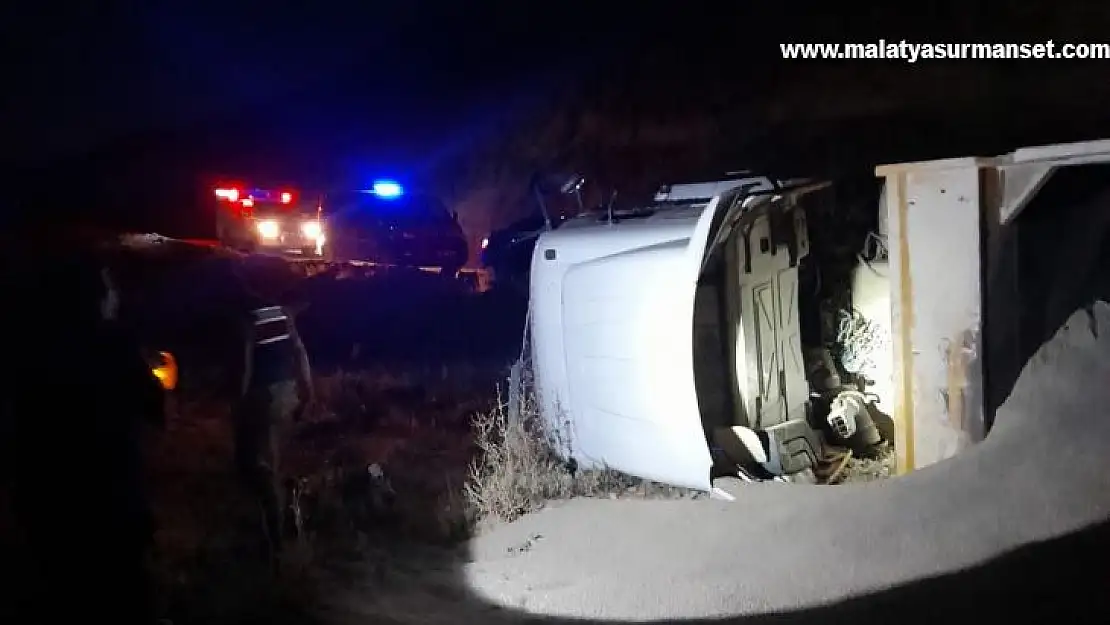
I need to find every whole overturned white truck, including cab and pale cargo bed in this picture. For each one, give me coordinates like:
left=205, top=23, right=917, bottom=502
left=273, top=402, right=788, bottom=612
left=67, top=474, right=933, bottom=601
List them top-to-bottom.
left=531, top=141, right=1110, bottom=492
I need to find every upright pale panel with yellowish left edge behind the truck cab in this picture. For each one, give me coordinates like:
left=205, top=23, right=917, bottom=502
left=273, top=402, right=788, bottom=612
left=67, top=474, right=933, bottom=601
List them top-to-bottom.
left=885, top=163, right=982, bottom=473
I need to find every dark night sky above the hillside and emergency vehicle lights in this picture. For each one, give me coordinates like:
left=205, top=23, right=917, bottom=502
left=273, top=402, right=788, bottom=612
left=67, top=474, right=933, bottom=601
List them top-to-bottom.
left=0, top=0, right=1110, bottom=232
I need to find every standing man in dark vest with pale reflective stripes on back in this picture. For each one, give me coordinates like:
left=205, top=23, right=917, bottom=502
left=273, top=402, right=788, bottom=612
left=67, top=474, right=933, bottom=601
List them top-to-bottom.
left=232, top=264, right=314, bottom=568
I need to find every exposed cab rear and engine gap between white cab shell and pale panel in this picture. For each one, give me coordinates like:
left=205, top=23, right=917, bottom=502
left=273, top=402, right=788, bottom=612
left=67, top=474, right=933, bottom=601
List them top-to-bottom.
left=692, top=175, right=891, bottom=482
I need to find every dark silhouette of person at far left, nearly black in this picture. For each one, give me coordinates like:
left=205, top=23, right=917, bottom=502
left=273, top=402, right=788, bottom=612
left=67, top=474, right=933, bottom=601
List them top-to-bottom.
left=2, top=254, right=164, bottom=623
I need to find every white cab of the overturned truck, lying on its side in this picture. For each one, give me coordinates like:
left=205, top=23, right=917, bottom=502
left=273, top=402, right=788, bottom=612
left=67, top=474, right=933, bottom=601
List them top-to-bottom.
left=532, top=172, right=880, bottom=488
